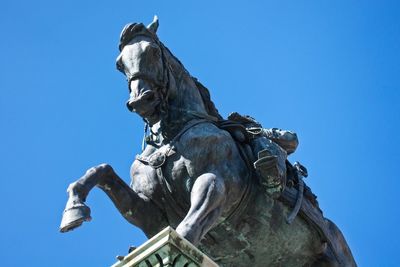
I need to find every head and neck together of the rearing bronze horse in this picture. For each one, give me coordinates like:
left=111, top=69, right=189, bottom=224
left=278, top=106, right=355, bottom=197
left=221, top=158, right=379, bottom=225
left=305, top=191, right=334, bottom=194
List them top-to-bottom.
left=117, top=17, right=222, bottom=130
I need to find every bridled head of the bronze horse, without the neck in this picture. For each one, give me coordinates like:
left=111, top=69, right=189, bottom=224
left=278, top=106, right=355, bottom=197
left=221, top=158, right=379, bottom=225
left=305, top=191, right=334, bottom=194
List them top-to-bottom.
left=117, top=17, right=170, bottom=124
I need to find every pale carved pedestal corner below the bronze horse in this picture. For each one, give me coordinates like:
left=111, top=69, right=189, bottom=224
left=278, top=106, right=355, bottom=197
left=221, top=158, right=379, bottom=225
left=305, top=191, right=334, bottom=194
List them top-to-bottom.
left=112, top=227, right=218, bottom=267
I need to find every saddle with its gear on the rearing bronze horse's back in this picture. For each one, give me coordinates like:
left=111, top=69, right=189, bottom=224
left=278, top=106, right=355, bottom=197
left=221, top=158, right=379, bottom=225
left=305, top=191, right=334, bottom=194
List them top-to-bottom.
left=218, top=112, right=298, bottom=199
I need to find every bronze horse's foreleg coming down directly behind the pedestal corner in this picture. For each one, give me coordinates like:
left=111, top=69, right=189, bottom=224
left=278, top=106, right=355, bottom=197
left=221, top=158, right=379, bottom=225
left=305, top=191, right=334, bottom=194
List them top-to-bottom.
left=176, top=173, right=226, bottom=245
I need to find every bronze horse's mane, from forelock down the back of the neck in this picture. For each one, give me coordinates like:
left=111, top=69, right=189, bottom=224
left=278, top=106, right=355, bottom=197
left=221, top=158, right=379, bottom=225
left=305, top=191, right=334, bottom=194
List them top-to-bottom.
left=117, top=23, right=223, bottom=120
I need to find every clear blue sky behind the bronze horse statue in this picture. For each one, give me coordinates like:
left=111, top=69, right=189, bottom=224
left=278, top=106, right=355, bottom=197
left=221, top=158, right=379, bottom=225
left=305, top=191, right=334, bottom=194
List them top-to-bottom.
left=0, top=0, right=400, bottom=267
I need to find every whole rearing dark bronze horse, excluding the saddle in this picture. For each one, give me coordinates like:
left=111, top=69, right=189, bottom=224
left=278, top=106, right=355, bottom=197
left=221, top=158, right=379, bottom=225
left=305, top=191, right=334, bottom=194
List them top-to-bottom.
left=60, top=18, right=356, bottom=266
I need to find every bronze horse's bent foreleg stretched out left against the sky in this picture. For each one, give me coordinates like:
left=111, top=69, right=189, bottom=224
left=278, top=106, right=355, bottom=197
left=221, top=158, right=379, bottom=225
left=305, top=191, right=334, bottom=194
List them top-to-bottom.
left=60, top=164, right=166, bottom=237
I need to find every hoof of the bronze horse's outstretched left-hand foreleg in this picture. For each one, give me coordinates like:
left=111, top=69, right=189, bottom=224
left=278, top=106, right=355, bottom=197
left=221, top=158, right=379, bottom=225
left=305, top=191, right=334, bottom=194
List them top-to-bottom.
left=60, top=203, right=92, bottom=233
